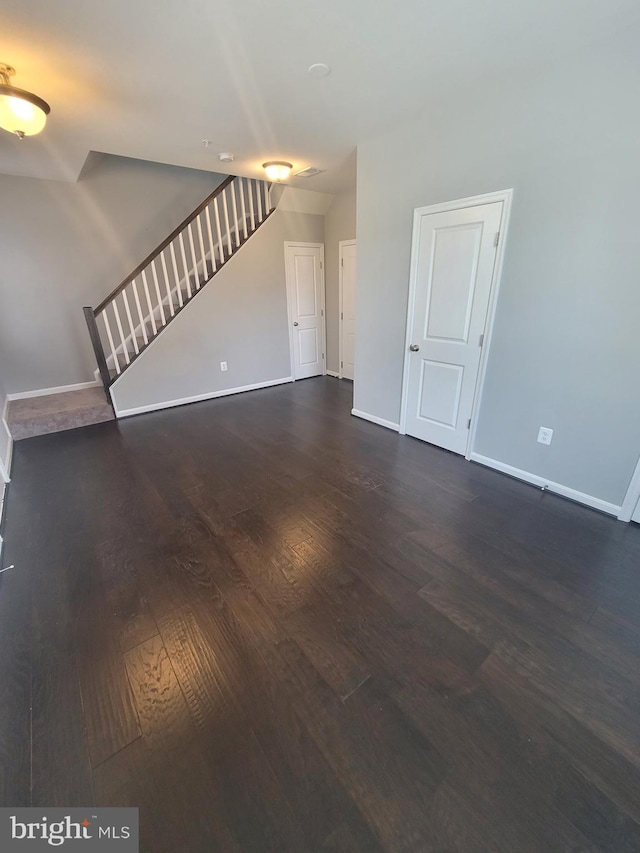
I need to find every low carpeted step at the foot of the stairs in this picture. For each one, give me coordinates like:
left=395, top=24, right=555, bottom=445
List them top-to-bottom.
left=7, top=388, right=114, bottom=441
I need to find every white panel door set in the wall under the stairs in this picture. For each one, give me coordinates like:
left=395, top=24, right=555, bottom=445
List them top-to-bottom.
left=286, top=243, right=324, bottom=379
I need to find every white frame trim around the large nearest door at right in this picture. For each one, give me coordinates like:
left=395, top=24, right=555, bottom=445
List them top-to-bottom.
left=399, top=188, right=513, bottom=459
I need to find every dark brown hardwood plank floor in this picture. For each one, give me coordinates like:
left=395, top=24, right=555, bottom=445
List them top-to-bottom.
left=0, top=379, right=640, bottom=853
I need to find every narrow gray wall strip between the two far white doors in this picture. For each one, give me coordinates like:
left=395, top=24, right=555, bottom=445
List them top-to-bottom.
left=324, top=188, right=356, bottom=373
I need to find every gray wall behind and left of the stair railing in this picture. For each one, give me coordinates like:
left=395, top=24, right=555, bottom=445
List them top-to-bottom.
left=0, top=154, right=224, bottom=393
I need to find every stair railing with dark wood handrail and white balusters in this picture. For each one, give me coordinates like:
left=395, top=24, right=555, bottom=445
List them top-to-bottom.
left=84, top=175, right=274, bottom=391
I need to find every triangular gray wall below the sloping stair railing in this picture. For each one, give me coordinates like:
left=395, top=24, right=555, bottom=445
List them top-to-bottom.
left=113, top=210, right=324, bottom=411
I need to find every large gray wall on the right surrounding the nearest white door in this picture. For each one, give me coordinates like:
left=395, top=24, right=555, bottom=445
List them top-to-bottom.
left=354, top=36, right=640, bottom=504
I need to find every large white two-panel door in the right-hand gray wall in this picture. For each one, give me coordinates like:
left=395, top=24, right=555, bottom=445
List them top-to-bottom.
left=405, top=201, right=503, bottom=453
